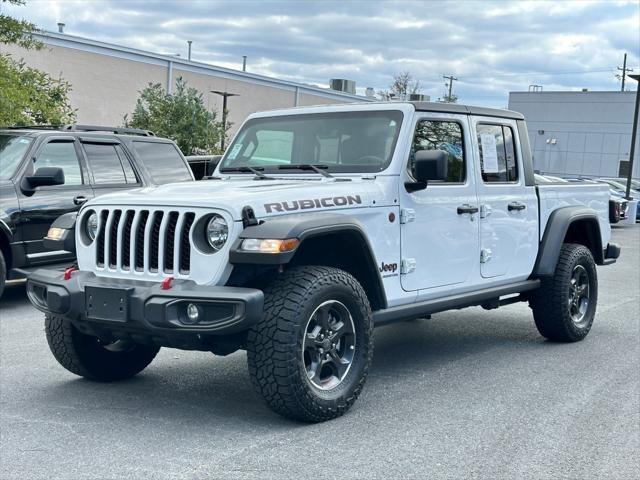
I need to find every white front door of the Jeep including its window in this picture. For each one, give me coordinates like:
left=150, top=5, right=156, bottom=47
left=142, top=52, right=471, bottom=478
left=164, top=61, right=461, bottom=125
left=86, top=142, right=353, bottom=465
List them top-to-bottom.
left=400, top=113, right=479, bottom=291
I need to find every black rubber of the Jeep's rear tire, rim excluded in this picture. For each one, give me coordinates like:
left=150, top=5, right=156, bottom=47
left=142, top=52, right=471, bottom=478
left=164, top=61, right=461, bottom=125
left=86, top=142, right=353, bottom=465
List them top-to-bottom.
left=529, top=243, right=598, bottom=342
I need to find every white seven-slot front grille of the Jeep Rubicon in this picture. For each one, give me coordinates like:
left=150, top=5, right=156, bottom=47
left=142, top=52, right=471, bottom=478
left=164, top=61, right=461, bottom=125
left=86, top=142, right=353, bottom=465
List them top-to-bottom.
left=96, top=209, right=195, bottom=275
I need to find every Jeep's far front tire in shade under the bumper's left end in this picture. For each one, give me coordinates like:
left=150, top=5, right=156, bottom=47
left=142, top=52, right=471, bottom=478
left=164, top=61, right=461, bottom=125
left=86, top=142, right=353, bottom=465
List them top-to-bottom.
left=45, top=315, right=160, bottom=382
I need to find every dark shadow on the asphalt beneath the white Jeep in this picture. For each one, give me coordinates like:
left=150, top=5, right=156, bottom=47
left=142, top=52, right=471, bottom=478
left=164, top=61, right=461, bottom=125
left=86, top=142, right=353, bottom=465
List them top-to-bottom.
left=35, top=313, right=548, bottom=429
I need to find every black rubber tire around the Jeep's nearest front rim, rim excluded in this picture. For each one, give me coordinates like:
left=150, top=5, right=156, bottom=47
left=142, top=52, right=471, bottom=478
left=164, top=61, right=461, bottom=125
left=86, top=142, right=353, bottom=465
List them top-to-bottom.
left=247, top=266, right=373, bottom=422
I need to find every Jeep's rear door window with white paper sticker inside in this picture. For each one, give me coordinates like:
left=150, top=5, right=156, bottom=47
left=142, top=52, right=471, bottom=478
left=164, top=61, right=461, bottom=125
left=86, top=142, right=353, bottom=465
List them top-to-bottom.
left=477, top=124, right=518, bottom=183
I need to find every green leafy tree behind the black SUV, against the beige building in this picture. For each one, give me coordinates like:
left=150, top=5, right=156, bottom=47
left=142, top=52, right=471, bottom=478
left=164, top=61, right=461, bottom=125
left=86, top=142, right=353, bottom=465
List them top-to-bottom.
left=124, top=77, right=229, bottom=155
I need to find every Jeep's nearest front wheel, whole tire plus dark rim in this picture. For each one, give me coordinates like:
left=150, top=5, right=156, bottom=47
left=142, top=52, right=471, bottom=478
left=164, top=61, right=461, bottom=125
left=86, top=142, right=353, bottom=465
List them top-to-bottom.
left=247, top=266, right=373, bottom=422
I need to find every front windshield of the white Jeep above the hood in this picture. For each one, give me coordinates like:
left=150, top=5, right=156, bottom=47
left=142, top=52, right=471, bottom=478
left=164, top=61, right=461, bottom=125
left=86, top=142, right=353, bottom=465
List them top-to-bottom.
left=220, top=110, right=402, bottom=173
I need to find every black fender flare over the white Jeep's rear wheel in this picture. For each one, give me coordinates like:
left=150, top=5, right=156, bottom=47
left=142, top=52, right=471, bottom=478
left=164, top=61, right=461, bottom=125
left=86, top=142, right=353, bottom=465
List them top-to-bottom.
left=533, top=206, right=604, bottom=277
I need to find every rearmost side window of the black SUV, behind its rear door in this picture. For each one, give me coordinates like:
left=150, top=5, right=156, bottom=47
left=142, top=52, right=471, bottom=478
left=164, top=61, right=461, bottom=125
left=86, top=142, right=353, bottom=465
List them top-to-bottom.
left=133, top=141, right=193, bottom=185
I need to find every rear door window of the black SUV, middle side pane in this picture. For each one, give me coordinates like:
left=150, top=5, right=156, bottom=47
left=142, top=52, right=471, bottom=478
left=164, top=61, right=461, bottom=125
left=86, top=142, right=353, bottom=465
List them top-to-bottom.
left=83, top=143, right=138, bottom=185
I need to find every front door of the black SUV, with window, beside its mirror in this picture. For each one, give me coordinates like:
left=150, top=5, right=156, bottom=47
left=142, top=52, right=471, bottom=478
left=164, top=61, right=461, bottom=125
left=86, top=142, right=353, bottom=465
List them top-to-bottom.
left=19, top=136, right=93, bottom=265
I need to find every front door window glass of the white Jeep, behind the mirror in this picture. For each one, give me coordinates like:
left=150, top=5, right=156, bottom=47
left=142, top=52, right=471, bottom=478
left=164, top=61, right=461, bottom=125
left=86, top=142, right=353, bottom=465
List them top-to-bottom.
left=409, top=120, right=466, bottom=183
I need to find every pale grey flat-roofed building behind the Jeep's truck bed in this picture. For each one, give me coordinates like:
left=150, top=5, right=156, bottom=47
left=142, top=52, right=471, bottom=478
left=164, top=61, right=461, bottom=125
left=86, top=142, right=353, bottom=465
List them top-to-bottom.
left=509, top=91, right=640, bottom=178
